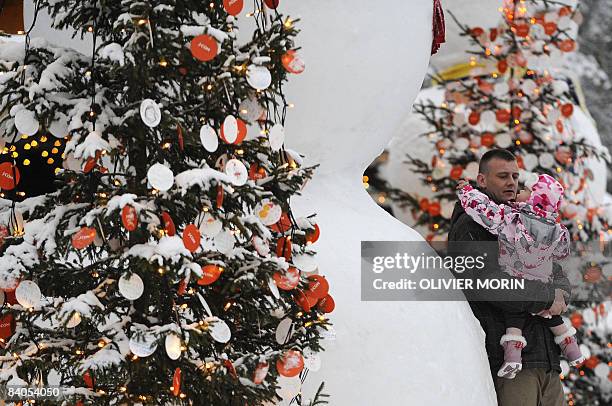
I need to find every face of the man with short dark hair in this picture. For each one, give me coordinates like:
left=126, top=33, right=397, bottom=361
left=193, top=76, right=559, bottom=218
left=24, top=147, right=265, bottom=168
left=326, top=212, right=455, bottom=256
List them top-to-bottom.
left=476, top=158, right=519, bottom=203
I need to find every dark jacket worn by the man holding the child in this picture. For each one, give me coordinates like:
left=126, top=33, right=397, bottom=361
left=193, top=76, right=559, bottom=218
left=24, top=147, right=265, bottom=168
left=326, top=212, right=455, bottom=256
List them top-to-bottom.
left=448, top=203, right=571, bottom=376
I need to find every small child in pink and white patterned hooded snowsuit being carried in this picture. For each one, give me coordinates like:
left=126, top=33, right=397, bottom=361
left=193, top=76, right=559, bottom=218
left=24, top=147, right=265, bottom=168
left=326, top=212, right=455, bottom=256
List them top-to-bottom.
left=457, top=175, right=584, bottom=379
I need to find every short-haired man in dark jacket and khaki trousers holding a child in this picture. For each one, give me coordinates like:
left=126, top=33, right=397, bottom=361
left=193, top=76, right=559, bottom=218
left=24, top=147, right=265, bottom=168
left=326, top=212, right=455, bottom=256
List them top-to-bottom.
left=448, top=149, right=570, bottom=406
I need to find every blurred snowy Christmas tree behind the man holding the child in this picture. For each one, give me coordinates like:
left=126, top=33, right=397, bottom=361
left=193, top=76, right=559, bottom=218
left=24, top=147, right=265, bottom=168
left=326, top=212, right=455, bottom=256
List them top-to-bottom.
left=370, top=0, right=612, bottom=405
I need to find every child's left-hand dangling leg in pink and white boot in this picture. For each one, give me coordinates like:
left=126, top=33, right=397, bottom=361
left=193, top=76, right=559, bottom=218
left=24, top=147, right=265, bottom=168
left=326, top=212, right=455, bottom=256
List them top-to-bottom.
left=497, top=312, right=527, bottom=379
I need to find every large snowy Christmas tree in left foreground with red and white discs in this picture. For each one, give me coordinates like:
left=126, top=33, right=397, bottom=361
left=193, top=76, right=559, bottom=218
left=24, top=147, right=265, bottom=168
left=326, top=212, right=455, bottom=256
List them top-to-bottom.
left=0, top=0, right=334, bottom=405
